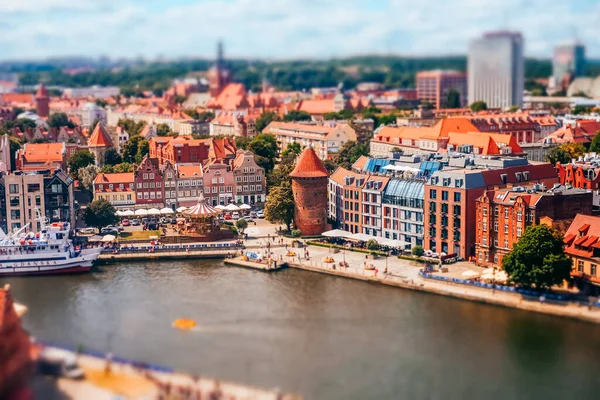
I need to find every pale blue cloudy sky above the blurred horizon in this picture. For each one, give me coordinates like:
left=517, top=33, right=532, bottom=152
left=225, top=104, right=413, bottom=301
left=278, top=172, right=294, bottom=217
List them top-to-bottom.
left=0, top=0, right=600, bottom=60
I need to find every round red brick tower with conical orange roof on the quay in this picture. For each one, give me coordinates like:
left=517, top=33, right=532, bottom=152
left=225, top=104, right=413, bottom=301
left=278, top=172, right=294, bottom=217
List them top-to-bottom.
left=290, top=147, right=329, bottom=236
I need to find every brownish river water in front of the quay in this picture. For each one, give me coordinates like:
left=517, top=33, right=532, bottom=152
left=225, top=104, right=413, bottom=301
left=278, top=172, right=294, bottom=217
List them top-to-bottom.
left=0, top=260, right=600, bottom=399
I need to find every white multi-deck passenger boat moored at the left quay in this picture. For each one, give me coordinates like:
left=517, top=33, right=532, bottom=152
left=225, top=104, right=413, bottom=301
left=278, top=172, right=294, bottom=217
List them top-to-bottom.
left=0, top=209, right=102, bottom=276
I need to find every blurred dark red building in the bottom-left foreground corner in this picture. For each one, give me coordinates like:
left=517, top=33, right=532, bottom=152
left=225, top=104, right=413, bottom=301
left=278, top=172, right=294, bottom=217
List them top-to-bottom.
left=0, top=285, right=32, bottom=399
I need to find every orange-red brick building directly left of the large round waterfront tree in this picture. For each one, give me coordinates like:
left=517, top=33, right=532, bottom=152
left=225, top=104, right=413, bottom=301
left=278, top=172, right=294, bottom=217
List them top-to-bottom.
left=475, top=185, right=592, bottom=265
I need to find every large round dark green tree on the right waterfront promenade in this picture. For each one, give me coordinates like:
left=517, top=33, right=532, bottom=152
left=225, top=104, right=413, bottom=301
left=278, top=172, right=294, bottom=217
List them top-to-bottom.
left=502, top=225, right=572, bottom=289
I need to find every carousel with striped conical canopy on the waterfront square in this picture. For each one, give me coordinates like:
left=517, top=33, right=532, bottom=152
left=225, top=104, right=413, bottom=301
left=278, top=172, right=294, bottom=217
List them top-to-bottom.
left=177, top=193, right=233, bottom=241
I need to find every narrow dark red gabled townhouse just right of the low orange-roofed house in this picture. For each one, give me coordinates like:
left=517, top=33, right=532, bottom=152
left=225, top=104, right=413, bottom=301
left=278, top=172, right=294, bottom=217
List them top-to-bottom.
left=133, top=156, right=165, bottom=208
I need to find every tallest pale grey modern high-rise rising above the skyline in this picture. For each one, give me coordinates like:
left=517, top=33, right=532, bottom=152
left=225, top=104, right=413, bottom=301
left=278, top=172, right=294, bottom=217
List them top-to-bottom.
left=467, top=31, right=525, bottom=108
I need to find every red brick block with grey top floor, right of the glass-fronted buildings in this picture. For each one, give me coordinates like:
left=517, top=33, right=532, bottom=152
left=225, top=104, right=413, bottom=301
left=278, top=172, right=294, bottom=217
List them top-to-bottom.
left=424, top=158, right=558, bottom=259
